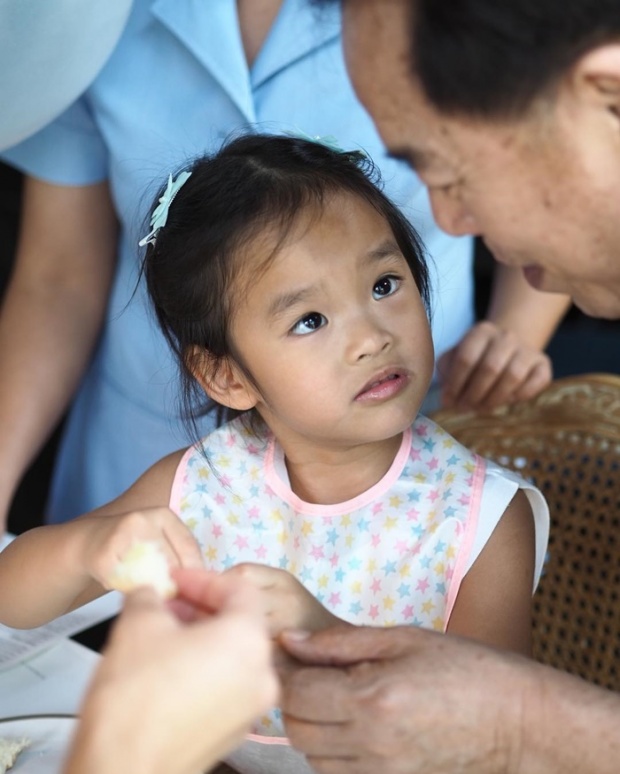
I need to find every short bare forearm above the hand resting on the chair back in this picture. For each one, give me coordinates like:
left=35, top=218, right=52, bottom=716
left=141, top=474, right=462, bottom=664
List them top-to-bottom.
left=486, top=265, right=571, bottom=350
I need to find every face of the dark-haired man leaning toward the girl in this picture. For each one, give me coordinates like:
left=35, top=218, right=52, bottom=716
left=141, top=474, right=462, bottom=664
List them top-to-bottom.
left=344, top=0, right=620, bottom=317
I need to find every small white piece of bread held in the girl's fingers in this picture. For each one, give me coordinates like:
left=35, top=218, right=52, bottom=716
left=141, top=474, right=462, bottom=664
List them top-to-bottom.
left=108, top=540, right=177, bottom=599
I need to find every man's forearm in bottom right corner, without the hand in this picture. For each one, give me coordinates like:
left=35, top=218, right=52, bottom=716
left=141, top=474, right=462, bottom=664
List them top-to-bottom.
left=511, top=668, right=620, bottom=774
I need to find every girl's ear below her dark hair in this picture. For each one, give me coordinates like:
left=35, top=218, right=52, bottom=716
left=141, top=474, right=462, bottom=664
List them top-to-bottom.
left=187, top=347, right=257, bottom=411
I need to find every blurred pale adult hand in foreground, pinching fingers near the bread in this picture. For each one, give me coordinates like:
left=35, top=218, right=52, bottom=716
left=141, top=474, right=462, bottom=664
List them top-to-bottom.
left=65, top=570, right=277, bottom=774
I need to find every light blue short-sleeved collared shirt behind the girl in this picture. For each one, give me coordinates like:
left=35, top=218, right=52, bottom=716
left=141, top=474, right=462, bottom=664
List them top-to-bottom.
left=4, top=0, right=473, bottom=520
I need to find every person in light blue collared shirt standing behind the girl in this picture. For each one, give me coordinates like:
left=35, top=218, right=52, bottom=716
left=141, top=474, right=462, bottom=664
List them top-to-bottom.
left=0, top=0, right=566, bottom=521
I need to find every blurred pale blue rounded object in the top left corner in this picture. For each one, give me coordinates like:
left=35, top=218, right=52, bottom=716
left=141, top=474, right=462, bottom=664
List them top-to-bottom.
left=0, top=0, right=131, bottom=150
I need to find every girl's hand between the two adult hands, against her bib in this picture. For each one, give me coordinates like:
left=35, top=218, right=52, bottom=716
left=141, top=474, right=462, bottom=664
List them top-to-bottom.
left=225, top=563, right=342, bottom=637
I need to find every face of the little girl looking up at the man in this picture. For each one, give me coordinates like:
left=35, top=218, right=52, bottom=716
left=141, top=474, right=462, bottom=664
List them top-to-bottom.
left=225, top=194, right=433, bottom=452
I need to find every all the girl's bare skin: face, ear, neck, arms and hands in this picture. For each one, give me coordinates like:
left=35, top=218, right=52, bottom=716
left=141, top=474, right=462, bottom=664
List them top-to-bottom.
left=0, top=189, right=535, bottom=654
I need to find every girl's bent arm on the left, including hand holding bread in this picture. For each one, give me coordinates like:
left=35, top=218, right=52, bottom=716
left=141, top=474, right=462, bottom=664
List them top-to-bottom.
left=0, top=452, right=203, bottom=628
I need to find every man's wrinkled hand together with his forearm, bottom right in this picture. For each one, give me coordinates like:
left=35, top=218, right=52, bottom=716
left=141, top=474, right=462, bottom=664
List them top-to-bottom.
left=280, top=627, right=620, bottom=774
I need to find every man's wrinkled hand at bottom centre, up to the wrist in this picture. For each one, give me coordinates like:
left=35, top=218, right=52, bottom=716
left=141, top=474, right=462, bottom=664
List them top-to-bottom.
left=280, top=627, right=533, bottom=774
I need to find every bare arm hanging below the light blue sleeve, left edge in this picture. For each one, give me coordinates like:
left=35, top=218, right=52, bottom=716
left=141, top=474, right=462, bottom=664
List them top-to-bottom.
left=0, top=179, right=117, bottom=527
